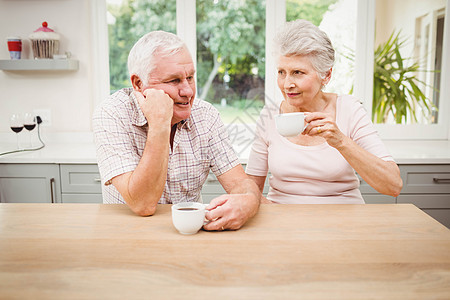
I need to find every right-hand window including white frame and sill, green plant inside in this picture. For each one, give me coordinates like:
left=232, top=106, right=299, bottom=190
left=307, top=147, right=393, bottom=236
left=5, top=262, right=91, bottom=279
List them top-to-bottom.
left=356, top=0, right=450, bottom=139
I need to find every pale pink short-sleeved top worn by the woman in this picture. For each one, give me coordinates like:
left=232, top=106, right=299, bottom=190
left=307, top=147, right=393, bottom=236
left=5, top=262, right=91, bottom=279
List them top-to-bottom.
left=246, top=95, right=394, bottom=204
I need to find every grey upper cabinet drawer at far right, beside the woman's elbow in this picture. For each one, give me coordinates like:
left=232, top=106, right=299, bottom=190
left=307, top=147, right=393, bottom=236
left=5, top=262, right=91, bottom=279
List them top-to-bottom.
left=400, top=165, right=450, bottom=194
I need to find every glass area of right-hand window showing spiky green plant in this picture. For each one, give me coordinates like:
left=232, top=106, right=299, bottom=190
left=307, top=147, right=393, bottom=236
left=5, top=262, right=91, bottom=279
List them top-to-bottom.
left=372, top=0, right=445, bottom=125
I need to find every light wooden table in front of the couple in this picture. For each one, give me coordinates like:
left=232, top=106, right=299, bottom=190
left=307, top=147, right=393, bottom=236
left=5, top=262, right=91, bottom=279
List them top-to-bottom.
left=0, top=204, right=450, bottom=299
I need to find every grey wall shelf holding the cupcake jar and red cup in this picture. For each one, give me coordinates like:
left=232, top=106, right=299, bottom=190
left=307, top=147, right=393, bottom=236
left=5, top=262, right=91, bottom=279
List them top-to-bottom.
left=0, top=59, right=78, bottom=71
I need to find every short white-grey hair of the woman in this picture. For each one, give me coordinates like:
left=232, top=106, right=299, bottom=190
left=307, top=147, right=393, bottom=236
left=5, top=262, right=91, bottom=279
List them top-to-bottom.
left=274, top=19, right=334, bottom=77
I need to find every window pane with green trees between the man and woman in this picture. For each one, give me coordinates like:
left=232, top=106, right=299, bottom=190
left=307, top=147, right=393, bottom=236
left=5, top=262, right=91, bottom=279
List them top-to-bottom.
left=196, top=0, right=266, bottom=124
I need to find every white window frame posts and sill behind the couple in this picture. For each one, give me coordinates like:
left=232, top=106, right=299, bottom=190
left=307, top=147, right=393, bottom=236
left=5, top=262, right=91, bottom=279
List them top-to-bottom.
left=95, top=0, right=450, bottom=140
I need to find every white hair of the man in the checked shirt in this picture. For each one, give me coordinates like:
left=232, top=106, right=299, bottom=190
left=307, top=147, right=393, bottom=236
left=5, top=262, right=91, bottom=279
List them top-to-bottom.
left=128, top=31, right=185, bottom=84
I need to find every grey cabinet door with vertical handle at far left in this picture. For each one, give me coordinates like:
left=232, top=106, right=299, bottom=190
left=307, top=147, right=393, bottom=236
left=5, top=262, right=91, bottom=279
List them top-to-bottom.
left=0, top=164, right=61, bottom=203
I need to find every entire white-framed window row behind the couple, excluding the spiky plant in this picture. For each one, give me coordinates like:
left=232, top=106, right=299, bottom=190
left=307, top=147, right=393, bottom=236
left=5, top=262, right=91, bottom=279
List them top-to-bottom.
left=91, top=0, right=450, bottom=143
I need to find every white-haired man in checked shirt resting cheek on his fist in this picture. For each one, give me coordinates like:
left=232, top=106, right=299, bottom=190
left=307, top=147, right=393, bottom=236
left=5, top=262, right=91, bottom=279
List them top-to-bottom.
left=93, top=31, right=261, bottom=230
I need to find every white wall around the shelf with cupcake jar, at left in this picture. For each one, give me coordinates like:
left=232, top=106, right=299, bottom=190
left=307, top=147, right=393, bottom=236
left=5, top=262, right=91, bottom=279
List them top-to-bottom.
left=0, top=0, right=99, bottom=135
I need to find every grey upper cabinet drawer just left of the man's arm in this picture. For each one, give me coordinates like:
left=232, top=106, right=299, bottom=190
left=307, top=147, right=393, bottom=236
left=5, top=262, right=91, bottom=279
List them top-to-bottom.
left=61, top=165, right=102, bottom=194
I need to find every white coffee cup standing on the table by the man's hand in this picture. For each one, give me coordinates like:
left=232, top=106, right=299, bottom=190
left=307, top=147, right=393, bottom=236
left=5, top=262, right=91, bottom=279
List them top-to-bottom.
left=172, top=202, right=206, bottom=234
